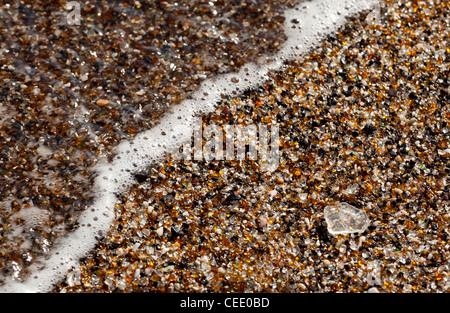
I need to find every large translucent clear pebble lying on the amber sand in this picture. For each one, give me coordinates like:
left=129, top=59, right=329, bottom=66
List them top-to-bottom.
left=324, top=202, right=369, bottom=235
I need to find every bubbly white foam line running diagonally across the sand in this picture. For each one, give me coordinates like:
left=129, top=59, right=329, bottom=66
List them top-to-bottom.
left=0, top=0, right=378, bottom=292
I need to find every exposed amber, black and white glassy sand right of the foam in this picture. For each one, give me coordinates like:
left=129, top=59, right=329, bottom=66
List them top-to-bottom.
left=54, top=1, right=450, bottom=292
